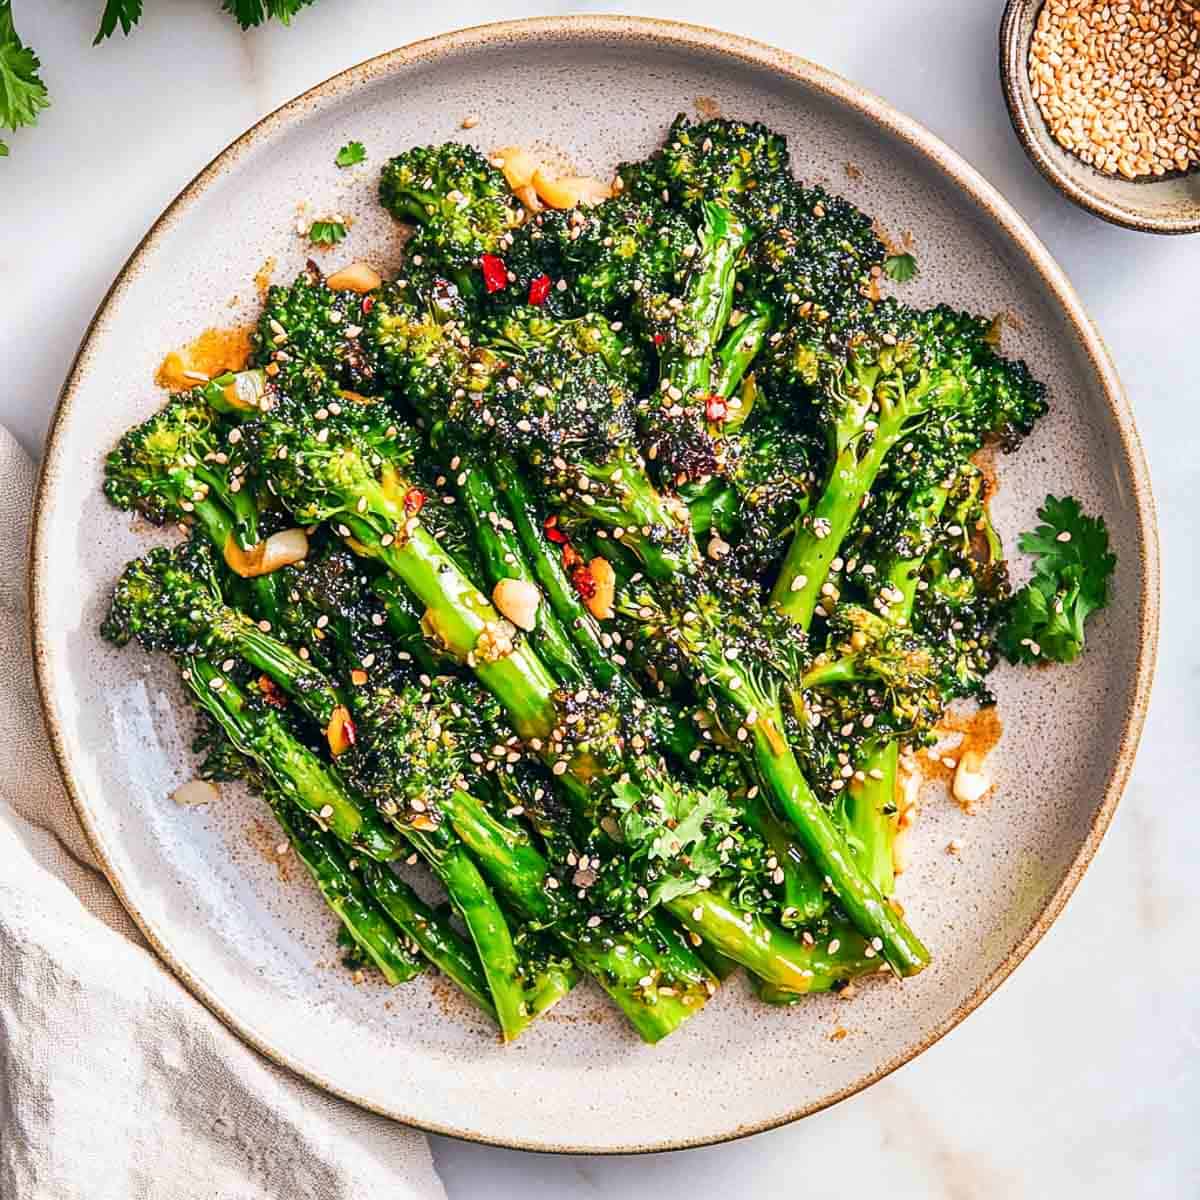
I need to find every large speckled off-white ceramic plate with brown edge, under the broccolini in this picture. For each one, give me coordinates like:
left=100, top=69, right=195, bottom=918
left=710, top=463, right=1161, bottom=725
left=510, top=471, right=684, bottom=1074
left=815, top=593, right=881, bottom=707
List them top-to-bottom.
left=32, top=17, right=1158, bottom=1152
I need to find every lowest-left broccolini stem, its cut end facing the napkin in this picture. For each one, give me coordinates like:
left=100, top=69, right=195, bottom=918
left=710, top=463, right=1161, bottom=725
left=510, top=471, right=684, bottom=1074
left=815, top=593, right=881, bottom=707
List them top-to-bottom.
left=269, top=791, right=424, bottom=984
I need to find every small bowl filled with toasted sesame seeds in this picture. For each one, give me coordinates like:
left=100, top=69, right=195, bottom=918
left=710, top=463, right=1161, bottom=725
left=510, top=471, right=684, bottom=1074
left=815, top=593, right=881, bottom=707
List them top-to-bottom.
left=1000, top=0, right=1200, bottom=233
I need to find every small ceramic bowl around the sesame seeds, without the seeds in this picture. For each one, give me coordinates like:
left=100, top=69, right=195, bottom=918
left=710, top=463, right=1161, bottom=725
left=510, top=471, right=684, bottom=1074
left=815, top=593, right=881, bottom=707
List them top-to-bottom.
left=1000, top=0, right=1200, bottom=233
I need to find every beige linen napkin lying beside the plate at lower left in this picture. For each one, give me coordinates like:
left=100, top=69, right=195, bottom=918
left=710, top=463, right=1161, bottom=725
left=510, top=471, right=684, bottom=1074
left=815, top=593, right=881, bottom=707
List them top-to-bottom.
left=0, top=427, right=445, bottom=1200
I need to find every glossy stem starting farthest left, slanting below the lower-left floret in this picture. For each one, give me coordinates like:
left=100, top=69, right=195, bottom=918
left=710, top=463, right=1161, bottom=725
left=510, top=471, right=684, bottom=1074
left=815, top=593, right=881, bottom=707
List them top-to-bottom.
left=180, top=656, right=404, bottom=862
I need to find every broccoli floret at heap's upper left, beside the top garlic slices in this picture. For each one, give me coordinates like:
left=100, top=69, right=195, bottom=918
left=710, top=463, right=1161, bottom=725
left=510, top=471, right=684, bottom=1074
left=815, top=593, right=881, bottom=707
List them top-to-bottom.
left=379, top=142, right=521, bottom=285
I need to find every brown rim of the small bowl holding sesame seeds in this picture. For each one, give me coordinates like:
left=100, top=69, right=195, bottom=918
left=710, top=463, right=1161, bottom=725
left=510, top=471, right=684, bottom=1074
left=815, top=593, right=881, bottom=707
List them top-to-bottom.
left=1000, top=0, right=1200, bottom=234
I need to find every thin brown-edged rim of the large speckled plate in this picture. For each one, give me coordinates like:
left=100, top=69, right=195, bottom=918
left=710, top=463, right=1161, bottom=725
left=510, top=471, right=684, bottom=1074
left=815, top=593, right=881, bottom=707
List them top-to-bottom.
left=28, top=13, right=1159, bottom=1154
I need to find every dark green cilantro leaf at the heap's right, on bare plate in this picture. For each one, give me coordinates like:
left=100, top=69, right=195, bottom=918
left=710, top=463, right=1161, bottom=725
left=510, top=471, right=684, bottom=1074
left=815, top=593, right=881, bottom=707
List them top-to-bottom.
left=1000, top=496, right=1117, bottom=664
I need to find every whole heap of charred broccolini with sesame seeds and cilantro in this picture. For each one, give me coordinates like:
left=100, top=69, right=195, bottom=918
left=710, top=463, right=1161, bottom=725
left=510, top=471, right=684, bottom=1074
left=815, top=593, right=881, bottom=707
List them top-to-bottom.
left=96, top=118, right=1112, bottom=1042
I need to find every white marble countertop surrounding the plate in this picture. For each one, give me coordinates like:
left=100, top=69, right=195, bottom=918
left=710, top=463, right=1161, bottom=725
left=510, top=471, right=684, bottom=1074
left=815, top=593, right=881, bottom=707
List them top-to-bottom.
left=0, top=0, right=1200, bottom=1200
